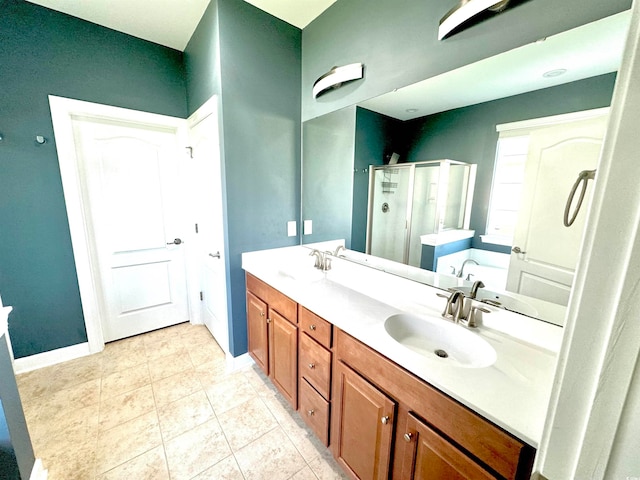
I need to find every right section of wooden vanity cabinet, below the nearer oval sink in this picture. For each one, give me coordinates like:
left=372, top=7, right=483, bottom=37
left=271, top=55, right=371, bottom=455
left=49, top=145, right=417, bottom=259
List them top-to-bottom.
left=331, top=329, right=535, bottom=480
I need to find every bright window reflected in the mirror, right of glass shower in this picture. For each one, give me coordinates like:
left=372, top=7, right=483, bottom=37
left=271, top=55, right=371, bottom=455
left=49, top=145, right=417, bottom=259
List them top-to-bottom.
left=483, top=135, right=529, bottom=246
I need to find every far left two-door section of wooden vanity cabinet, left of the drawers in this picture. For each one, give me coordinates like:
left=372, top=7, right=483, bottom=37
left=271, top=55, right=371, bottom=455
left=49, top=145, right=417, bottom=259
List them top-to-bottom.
left=247, top=274, right=298, bottom=409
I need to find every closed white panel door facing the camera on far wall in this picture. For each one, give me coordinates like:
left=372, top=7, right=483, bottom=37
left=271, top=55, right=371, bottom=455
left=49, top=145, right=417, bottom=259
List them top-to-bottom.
left=72, top=117, right=189, bottom=341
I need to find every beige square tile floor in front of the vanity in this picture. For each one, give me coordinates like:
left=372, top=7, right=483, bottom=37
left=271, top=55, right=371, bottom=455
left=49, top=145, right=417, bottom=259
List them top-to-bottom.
left=18, top=323, right=346, bottom=480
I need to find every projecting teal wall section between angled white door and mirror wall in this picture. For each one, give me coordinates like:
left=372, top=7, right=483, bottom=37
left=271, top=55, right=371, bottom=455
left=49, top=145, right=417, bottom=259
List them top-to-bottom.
left=185, top=0, right=301, bottom=356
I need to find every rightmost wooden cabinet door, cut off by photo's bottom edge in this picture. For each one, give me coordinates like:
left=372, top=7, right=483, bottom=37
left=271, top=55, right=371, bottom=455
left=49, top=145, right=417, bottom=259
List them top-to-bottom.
left=400, top=414, right=501, bottom=480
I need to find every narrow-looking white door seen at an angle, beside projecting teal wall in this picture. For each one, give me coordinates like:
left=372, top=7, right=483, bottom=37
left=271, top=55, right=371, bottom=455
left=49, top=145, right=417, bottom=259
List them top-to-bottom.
left=189, top=97, right=229, bottom=353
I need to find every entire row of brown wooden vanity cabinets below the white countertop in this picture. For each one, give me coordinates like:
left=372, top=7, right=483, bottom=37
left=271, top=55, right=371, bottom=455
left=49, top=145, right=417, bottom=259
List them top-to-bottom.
left=247, top=274, right=535, bottom=480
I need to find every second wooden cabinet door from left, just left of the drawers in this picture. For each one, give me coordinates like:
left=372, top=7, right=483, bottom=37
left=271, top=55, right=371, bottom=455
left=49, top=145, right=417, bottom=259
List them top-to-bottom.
left=269, top=309, right=298, bottom=409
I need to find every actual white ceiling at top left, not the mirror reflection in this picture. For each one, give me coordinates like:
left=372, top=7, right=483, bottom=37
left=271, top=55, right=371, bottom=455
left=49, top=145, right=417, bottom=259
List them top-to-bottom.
left=27, top=0, right=336, bottom=51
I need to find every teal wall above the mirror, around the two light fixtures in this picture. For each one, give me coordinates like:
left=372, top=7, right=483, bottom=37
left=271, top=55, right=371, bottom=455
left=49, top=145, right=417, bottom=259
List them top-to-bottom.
left=302, top=0, right=631, bottom=120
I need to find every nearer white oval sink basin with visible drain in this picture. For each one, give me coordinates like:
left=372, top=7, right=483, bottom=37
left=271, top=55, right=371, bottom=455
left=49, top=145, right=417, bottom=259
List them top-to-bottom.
left=384, top=313, right=496, bottom=368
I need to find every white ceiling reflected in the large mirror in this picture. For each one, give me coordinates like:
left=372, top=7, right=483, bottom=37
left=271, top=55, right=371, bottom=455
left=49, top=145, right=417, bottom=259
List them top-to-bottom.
left=360, top=11, right=631, bottom=120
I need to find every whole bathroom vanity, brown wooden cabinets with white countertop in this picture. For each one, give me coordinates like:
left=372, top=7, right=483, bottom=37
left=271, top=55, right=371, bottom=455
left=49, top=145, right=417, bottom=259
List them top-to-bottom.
left=243, top=247, right=561, bottom=479
